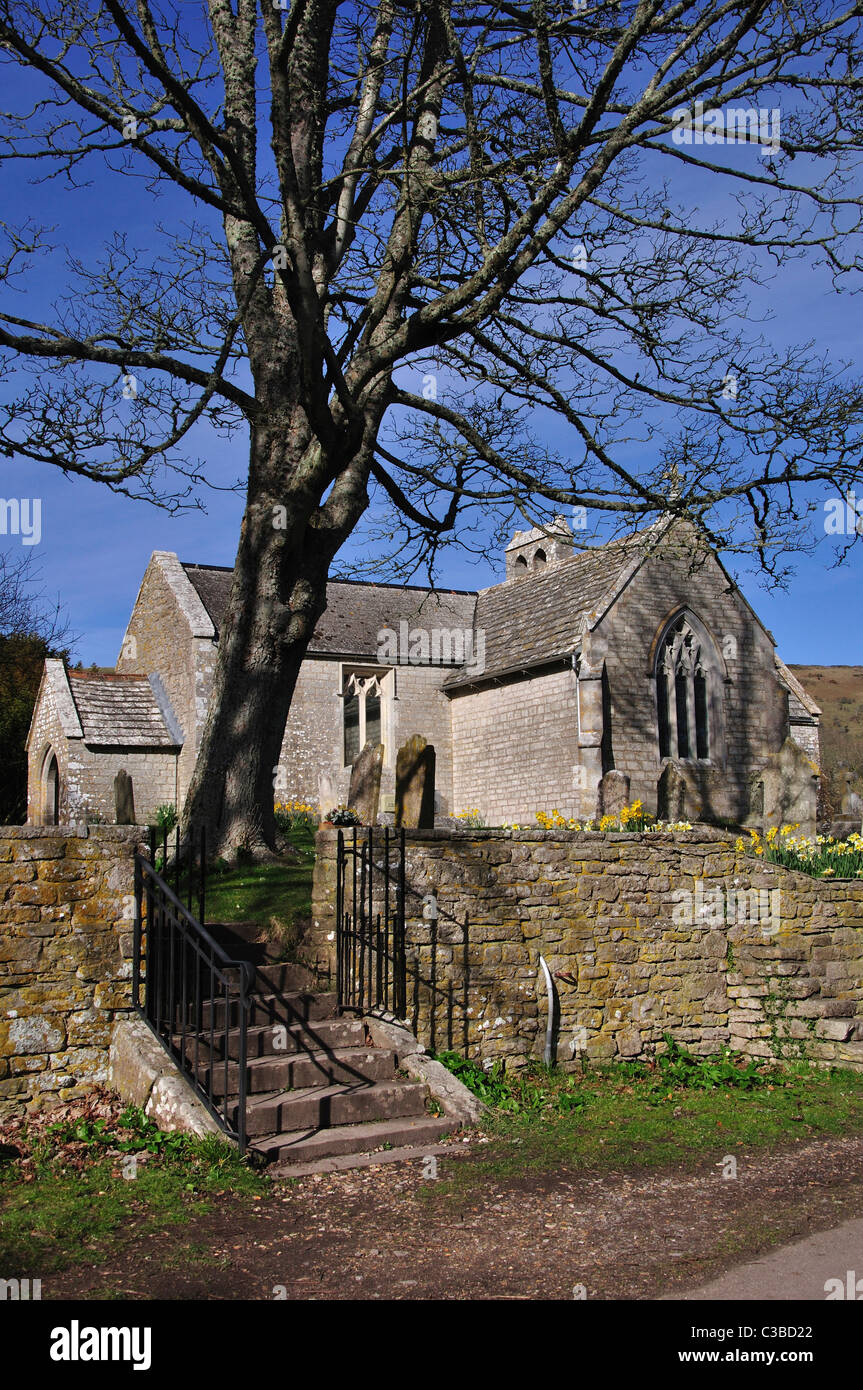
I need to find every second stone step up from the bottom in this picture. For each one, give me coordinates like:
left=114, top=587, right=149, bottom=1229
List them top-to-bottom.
left=229, top=1080, right=425, bottom=1138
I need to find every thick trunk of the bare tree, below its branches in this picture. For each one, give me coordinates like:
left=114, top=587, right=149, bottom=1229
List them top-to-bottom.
left=183, top=417, right=342, bottom=853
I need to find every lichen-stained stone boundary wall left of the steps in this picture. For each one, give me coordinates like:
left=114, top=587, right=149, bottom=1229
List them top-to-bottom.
left=0, top=826, right=140, bottom=1113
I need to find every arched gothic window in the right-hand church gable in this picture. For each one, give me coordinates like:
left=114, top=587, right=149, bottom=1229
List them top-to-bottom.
left=656, top=616, right=712, bottom=760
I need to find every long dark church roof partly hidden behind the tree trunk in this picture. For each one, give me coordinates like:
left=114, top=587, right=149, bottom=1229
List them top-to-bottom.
left=183, top=564, right=477, bottom=660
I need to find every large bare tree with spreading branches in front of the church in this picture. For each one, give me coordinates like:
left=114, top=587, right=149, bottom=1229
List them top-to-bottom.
left=0, top=0, right=863, bottom=845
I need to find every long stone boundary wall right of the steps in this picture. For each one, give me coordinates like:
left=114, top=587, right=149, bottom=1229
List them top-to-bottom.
left=303, top=827, right=863, bottom=1069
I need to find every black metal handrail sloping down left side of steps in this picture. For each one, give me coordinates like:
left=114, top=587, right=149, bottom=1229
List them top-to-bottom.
left=132, top=855, right=254, bottom=1154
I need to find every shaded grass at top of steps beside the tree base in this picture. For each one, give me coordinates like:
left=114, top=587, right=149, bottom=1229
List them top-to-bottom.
left=201, top=827, right=314, bottom=923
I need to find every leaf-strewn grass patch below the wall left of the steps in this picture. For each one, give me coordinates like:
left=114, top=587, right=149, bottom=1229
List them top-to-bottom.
left=0, top=1126, right=270, bottom=1277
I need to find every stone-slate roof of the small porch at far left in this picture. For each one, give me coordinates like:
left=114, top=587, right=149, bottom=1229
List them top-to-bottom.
left=68, top=671, right=178, bottom=748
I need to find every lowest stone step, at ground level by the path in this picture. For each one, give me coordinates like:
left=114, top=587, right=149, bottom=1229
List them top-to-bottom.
left=250, top=1115, right=459, bottom=1176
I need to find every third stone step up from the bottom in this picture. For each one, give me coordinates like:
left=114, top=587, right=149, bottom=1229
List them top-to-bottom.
left=199, top=1048, right=397, bottom=1097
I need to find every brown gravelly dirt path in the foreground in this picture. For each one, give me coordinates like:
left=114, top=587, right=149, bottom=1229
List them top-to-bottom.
left=43, top=1137, right=863, bottom=1300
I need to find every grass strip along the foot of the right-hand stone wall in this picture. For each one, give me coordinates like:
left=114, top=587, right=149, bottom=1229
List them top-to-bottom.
left=424, top=1056, right=863, bottom=1195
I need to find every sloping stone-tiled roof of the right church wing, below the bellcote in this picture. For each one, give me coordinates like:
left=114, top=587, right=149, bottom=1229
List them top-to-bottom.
left=445, top=527, right=653, bottom=689
